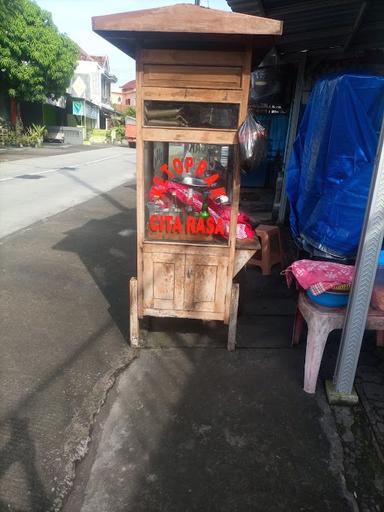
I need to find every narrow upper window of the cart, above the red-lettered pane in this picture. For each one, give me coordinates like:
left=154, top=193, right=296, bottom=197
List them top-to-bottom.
left=144, top=101, right=239, bottom=130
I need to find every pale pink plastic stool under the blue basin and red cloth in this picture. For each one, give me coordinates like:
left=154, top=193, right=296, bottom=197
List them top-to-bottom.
left=292, top=292, right=384, bottom=393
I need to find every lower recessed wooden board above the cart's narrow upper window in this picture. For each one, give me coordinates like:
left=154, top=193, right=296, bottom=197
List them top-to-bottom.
left=143, top=64, right=242, bottom=89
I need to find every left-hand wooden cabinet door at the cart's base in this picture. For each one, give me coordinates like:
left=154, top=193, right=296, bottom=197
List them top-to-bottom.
left=143, top=252, right=185, bottom=310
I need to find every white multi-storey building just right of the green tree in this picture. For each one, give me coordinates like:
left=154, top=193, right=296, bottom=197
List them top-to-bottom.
left=67, top=50, right=117, bottom=129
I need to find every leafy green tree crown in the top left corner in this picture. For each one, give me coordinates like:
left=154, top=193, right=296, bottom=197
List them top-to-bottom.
left=0, top=0, right=79, bottom=102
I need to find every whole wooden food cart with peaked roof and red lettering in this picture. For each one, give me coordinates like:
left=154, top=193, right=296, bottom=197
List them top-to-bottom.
left=92, top=4, right=282, bottom=350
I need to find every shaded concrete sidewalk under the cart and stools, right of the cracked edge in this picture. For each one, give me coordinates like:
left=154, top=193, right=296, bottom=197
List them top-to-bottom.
left=64, top=270, right=384, bottom=512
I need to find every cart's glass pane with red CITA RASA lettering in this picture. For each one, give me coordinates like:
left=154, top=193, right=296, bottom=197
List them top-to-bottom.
left=144, top=142, right=234, bottom=245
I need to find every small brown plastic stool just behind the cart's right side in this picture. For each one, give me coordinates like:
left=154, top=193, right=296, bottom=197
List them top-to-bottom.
left=251, top=224, right=284, bottom=276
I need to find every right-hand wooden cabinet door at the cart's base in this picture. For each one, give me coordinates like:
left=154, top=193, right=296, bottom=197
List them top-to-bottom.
left=184, top=255, right=228, bottom=313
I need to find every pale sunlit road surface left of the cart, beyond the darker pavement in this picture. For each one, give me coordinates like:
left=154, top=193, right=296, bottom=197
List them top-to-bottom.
left=0, top=147, right=136, bottom=237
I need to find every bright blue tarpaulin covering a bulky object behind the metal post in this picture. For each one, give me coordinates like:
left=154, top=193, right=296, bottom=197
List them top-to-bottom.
left=286, top=74, right=384, bottom=258
